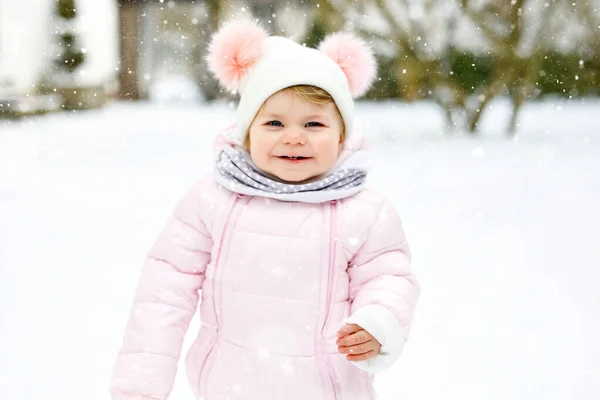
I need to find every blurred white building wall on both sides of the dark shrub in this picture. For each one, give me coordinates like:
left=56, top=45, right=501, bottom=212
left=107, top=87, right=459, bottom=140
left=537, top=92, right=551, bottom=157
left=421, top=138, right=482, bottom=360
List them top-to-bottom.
left=0, top=0, right=119, bottom=94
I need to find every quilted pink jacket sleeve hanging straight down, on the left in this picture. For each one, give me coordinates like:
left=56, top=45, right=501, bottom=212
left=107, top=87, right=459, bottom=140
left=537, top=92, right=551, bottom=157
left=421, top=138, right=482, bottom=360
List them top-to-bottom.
left=110, top=186, right=212, bottom=400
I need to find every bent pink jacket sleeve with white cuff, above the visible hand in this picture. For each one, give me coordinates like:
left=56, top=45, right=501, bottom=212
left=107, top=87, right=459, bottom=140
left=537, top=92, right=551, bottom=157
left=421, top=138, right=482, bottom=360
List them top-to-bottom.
left=344, top=202, right=420, bottom=373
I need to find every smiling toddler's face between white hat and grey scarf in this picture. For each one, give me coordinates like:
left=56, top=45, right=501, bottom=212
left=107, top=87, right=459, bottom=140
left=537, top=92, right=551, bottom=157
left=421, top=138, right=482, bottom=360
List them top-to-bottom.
left=249, top=90, right=343, bottom=183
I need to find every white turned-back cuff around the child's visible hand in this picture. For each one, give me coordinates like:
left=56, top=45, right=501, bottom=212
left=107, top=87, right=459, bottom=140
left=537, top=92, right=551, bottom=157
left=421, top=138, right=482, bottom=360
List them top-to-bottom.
left=344, top=304, right=404, bottom=374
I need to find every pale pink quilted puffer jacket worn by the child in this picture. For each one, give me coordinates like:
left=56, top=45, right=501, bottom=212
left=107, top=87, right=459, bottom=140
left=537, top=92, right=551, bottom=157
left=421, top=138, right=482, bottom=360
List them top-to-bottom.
left=111, top=141, right=419, bottom=400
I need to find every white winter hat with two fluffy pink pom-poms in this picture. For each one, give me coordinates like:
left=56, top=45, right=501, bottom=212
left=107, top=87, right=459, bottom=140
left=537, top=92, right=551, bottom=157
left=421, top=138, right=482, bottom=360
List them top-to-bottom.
left=207, top=19, right=377, bottom=145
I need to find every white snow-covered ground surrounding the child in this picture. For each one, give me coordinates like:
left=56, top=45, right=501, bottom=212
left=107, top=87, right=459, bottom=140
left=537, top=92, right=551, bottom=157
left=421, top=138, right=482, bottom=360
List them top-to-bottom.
left=0, top=97, right=600, bottom=400
